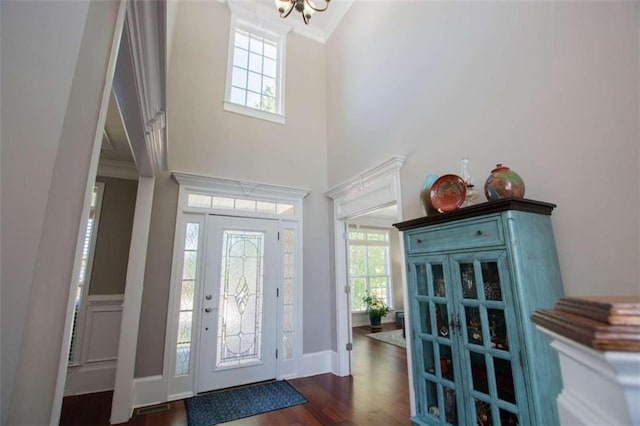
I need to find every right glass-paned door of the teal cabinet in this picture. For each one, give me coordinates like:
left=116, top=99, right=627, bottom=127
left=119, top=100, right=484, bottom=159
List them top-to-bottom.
left=451, top=252, right=527, bottom=426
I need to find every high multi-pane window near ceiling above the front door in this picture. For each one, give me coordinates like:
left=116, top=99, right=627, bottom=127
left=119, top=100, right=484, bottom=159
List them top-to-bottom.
left=224, top=16, right=286, bottom=124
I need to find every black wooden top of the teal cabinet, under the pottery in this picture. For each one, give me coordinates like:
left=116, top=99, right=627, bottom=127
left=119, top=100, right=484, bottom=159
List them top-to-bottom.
left=393, top=198, right=556, bottom=231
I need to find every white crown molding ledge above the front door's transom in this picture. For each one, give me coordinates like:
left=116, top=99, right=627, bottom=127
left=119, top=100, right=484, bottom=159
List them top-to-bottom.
left=172, top=171, right=311, bottom=201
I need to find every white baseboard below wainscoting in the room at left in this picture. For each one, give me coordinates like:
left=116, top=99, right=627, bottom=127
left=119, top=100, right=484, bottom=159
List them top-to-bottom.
left=64, top=362, right=116, bottom=396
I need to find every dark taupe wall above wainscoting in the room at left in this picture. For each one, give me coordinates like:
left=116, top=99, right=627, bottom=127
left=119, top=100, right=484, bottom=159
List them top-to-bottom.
left=89, top=176, right=138, bottom=294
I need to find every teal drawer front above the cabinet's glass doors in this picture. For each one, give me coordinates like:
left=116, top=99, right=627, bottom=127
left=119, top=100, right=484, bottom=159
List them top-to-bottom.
left=407, top=217, right=504, bottom=253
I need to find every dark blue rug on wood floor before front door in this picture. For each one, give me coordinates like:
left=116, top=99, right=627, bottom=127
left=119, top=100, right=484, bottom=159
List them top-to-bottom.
left=184, top=380, right=309, bottom=426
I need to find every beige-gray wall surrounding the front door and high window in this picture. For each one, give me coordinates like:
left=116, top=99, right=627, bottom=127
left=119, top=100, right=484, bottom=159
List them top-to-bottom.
left=136, top=1, right=334, bottom=377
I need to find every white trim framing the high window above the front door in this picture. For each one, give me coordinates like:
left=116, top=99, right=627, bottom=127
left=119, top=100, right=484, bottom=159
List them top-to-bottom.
left=223, top=8, right=292, bottom=124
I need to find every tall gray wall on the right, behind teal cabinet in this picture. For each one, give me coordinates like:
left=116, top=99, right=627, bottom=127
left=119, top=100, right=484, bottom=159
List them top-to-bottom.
left=326, top=1, right=640, bottom=295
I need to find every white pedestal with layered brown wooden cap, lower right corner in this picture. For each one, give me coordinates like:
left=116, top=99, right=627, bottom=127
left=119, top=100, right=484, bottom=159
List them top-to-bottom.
left=532, top=297, right=640, bottom=426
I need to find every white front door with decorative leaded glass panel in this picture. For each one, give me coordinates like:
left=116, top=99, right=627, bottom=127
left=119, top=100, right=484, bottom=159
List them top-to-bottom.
left=197, top=215, right=279, bottom=392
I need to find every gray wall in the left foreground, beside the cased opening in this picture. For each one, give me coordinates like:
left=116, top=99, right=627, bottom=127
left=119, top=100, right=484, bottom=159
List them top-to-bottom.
left=0, top=1, right=118, bottom=424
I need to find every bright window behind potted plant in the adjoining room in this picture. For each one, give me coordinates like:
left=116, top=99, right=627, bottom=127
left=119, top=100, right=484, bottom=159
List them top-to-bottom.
left=348, top=226, right=393, bottom=312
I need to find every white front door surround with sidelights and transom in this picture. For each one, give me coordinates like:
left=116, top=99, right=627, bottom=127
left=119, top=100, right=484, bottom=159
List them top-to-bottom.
left=164, top=172, right=309, bottom=405
